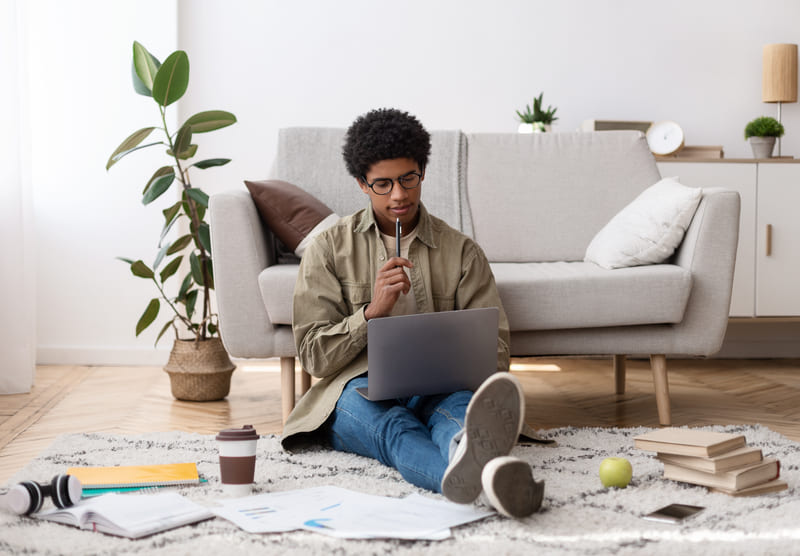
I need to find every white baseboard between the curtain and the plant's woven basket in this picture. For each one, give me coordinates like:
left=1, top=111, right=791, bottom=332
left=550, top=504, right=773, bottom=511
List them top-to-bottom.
left=36, top=346, right=170, bottom=367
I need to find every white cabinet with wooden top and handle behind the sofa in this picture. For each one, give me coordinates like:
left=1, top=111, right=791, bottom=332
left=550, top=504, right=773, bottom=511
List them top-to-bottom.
left=658, top=160, right=800, bottom=317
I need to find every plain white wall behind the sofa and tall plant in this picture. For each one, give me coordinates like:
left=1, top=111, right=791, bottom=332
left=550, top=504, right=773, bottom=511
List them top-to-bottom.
left=21, top=0, right=800, bottom=363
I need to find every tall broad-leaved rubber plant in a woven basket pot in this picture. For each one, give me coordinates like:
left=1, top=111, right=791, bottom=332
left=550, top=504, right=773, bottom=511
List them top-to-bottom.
left=106, top=41, right=236, bottom=401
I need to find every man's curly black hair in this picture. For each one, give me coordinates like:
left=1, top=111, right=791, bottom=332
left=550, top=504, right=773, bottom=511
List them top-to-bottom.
left=342, top=108, right=431, bottom=179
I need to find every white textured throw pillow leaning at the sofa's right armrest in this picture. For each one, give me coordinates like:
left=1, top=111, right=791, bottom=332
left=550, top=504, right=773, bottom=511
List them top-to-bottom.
left=584, top=178, right=703, bottom=268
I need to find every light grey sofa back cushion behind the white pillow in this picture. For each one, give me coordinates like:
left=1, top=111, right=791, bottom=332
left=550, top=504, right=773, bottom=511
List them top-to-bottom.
left=466, top=131, right=661, bottom=262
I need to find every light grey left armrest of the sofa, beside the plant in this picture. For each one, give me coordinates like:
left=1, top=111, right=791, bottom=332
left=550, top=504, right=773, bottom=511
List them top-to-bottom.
left=209, top=191, right=283, bottom=358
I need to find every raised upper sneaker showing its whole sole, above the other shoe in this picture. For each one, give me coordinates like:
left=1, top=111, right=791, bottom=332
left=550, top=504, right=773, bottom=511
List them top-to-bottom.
left=442, top=372, right=525, bottom=504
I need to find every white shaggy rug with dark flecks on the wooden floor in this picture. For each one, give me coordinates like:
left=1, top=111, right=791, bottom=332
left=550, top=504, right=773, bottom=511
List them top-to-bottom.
left=0, top=426, right=800, bottom=556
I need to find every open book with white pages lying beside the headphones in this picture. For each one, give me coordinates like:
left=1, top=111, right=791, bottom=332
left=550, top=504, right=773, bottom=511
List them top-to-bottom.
left=36, top=492, right=214, bottom=539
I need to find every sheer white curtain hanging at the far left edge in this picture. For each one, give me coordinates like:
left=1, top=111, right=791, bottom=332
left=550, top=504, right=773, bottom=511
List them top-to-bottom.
left=0, top=0, right=36, bottom=394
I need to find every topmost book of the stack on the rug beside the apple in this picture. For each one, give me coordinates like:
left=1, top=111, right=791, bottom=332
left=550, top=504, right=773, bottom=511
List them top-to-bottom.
left=633, top=427, right=746, bottom=458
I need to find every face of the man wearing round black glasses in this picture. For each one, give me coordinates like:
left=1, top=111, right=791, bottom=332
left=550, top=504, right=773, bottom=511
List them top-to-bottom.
left=358, top=158, right=425, bottom=236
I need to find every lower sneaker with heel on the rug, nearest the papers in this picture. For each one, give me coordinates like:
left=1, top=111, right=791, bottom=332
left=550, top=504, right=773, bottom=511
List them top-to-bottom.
left=481, top=456, right=544, bottom=518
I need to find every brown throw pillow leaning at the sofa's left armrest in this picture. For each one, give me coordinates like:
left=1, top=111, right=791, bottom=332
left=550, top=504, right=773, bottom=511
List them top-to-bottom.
left=244, top=180, right=333, bottom=251
